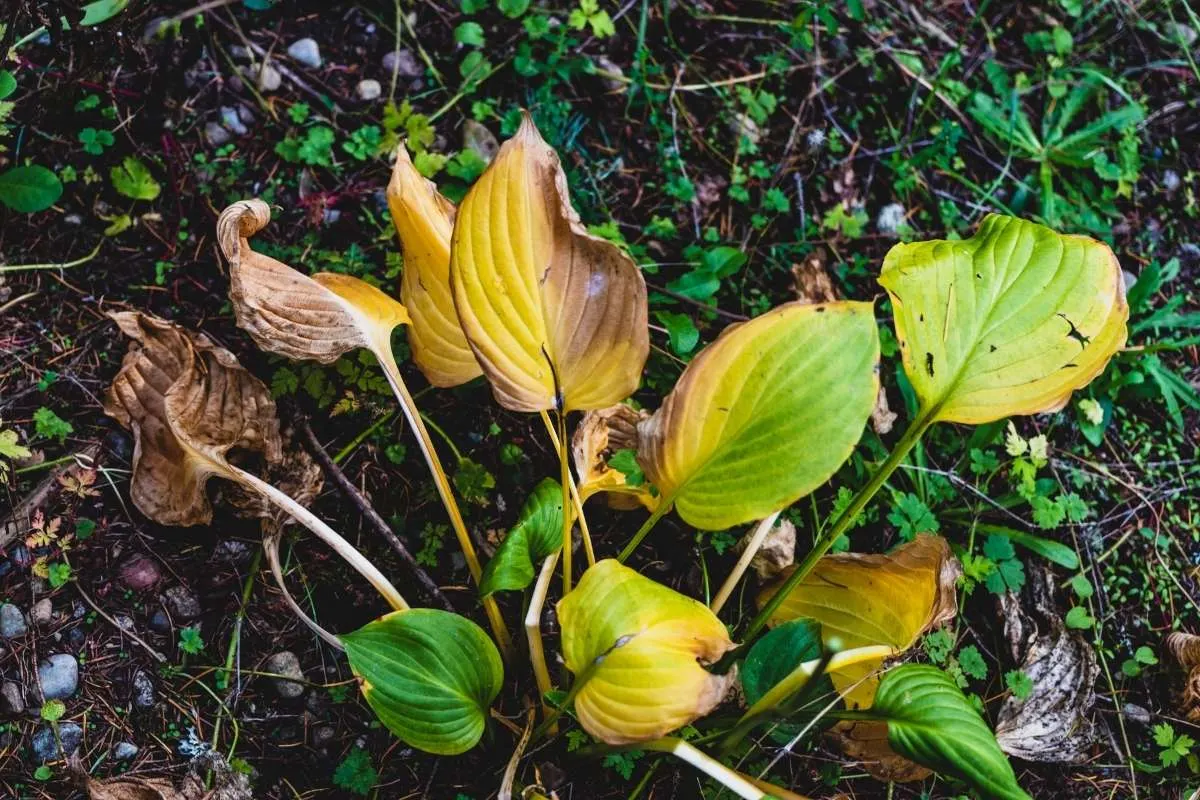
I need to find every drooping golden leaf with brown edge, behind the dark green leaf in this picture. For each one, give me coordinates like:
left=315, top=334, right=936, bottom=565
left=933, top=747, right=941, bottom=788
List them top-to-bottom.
left=758, top=534, right=960, bottom=708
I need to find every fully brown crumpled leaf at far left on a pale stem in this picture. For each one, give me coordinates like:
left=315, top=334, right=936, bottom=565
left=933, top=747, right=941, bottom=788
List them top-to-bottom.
left=104, top=312, right=282, bottom=525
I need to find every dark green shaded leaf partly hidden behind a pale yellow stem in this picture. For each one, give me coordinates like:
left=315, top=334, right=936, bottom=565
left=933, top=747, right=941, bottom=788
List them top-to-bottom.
left=739, top=619, right=834, bottom=742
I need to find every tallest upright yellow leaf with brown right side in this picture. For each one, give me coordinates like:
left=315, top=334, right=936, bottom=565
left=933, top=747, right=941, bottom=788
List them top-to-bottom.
left=450, top=115, right=649, bottom=411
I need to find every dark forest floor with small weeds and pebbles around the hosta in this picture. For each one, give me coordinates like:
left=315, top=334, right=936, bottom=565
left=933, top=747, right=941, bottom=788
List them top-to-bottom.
left=0, top=0, right=1200, bottom=800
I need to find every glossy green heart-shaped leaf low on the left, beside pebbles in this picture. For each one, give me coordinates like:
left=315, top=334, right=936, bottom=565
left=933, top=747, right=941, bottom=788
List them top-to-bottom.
left=341, top=608, right=504, bottom=756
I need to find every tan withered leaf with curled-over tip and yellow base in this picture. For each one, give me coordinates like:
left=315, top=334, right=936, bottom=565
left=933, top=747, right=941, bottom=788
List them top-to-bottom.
left=217, top=199, right=408, bottom=363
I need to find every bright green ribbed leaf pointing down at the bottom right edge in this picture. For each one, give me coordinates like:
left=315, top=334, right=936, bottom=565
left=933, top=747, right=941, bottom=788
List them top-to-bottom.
left=870, top=664, right=1030, bottom=800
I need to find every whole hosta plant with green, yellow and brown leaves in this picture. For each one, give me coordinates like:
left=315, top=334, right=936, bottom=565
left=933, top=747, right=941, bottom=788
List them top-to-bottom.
left=106, top=116, right=1128, bottom=800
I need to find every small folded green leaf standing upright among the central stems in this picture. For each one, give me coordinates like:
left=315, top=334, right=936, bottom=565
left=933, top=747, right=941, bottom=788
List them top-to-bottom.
left=479, top=477, right=563, bottom=595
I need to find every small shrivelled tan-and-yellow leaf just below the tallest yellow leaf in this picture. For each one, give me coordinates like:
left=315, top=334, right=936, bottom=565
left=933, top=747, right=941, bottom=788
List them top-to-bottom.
left=571, top=403, right=659, bottom=511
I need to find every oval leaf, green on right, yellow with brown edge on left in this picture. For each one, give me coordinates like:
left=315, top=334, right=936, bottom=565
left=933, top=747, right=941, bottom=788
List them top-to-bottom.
left=638, top=302, right=880, bottom=530
